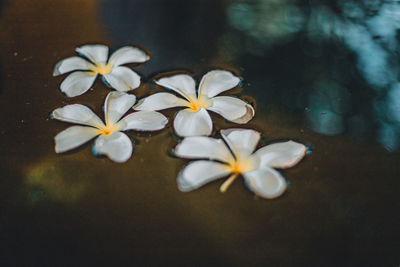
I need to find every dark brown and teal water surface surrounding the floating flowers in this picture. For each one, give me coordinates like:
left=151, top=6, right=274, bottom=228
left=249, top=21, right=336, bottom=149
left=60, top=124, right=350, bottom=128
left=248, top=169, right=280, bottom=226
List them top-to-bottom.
left=0, top=0, right=400, bottom=266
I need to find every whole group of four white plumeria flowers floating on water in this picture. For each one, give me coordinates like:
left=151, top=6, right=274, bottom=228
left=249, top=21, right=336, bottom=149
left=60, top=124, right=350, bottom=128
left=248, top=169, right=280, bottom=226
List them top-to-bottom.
left=52, top=45, right=306, bottom=198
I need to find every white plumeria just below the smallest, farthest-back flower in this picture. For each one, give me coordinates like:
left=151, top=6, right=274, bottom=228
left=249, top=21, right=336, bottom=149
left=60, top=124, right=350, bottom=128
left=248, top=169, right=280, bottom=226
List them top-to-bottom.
left=52, top=91, right=168, bottom=162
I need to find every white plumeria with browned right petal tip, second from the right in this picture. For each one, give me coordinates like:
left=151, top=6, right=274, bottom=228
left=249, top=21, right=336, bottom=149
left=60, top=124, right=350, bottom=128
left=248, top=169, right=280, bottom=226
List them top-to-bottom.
left=134, top=70, right=254, bottom=137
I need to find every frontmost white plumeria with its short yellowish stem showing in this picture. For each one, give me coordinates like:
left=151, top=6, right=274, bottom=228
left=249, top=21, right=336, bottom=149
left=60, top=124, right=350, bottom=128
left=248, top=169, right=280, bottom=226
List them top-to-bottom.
left=175, top=129, right=306, bottom=199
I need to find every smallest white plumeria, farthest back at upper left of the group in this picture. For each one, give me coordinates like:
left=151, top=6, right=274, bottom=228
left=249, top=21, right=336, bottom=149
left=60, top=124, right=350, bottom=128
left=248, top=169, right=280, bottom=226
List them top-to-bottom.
left=53, top=45, right=149, bottom=97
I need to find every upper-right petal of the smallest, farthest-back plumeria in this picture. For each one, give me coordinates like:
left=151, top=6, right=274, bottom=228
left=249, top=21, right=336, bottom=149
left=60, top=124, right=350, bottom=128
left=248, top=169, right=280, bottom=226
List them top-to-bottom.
left=108, top=46, right=149, bottom=67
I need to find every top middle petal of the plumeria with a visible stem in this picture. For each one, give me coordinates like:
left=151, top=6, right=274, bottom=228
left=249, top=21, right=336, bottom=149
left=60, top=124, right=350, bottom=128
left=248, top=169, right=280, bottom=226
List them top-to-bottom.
left=221, top=129, right=260, bottom=157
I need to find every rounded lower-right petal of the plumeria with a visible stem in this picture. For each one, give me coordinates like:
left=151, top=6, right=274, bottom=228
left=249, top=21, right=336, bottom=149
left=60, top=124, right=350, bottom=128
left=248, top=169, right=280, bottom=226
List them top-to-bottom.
left=243, top=168, right=286, bottom=199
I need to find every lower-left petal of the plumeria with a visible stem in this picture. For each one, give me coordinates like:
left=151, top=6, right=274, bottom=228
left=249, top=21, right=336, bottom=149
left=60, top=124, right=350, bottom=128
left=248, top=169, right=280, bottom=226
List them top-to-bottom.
left=177, top=160, right=231, bottom=192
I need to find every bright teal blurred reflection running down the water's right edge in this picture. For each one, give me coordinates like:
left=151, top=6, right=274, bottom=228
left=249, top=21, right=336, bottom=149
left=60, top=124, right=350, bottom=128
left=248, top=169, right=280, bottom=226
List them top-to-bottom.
left=311, top=1, right=400, bottom=151
